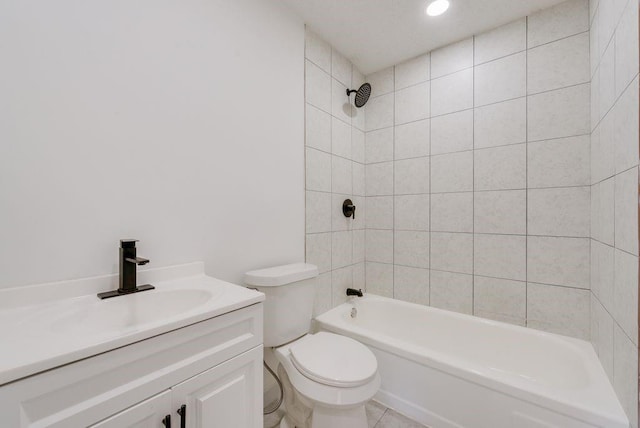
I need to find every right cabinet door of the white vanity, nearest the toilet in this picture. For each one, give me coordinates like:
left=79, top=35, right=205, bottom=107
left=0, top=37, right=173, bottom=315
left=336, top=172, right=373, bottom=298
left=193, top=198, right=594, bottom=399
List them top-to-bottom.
left=171, top=346, right=262, bottom=428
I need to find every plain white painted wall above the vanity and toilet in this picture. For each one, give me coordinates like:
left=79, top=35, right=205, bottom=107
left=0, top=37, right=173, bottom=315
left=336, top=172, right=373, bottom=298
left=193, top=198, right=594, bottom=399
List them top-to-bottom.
left=0, top=0, right=304, bottom=288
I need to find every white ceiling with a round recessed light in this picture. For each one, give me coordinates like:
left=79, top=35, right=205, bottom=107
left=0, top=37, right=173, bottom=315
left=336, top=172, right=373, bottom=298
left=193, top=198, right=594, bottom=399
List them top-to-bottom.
left=281, top=0, right=563, bottom=74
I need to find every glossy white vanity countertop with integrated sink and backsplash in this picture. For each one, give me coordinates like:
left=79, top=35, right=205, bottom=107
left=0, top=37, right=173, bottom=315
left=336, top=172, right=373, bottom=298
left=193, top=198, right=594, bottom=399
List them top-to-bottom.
left=0, top=263, right=264, bottom=386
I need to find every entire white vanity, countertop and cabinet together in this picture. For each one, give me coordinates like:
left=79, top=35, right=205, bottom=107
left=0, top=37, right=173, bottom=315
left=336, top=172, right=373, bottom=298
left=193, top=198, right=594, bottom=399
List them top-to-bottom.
left=0, top=263, right=264, bottom=428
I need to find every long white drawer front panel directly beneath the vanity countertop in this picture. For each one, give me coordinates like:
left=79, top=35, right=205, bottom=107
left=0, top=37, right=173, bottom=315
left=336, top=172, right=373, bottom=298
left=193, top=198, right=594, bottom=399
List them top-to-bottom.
left=0, top=304, right=262, bottom=428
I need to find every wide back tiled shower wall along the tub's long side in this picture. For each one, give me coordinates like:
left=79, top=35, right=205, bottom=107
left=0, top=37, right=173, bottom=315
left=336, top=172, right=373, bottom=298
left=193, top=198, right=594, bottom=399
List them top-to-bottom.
left=365, top=0, right=591, bottom=339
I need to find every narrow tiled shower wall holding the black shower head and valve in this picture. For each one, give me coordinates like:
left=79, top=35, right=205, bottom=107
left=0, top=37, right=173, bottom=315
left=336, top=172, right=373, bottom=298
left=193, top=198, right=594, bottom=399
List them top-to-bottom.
left=305, top=30, right=365, bottom=314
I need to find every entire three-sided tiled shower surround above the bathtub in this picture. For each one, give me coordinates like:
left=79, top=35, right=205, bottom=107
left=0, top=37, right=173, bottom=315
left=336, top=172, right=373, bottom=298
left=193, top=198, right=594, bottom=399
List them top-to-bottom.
left=305, top=0, right=638, bottom=426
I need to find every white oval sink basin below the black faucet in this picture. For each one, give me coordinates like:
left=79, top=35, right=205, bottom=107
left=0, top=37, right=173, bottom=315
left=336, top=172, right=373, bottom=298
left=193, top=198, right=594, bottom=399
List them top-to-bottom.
left=49, top=289, right=215, bottom=332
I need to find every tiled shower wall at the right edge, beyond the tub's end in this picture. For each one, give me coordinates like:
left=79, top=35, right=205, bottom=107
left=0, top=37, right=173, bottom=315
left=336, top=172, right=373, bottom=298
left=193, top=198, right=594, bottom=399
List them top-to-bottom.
left=590, top=0, right=640, bottom=427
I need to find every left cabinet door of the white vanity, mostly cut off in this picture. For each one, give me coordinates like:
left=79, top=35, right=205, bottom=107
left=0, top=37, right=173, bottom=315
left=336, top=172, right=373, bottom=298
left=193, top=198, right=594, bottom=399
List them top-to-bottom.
left=91, top=391, right=172, bottom=428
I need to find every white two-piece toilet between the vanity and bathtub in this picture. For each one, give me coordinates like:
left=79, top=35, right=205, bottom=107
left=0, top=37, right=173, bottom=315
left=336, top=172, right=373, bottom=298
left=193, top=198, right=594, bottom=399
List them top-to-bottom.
left=245, top=263, right=380, bottom=428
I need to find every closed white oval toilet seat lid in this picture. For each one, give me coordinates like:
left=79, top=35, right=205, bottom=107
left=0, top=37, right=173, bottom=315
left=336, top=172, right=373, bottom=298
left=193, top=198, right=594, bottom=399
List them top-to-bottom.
left=290, top=332, right=378, bottom=388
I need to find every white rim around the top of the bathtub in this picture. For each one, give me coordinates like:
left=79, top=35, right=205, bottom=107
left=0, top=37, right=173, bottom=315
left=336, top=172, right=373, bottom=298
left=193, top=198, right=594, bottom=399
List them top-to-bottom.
left=314, top=293, right=629, bottom=428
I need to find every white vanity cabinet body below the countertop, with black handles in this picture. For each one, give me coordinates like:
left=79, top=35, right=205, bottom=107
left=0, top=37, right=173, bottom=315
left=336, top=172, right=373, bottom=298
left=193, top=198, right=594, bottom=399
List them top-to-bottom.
left=0, top=303, right=262, bottom=428
